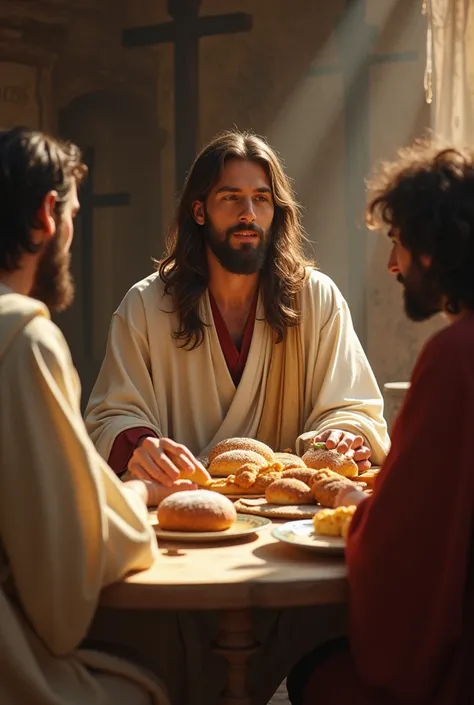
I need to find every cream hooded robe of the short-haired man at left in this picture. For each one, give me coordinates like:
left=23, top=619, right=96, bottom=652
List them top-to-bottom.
left=0, top=285, right=168, bottom=705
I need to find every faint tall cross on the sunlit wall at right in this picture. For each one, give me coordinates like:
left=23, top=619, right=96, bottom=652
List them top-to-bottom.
left=308, top=0, right=419, bottom=344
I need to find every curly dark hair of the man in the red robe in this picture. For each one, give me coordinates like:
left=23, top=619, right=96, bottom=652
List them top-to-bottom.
left=366, top=137, right=474, bottom=314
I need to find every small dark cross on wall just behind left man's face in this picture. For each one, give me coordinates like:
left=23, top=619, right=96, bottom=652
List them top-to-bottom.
left=80, top=147, right=130, bottom=358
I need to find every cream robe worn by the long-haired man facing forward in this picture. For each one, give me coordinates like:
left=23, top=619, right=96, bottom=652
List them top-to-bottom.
left=86, top=270, right=389, bottom=464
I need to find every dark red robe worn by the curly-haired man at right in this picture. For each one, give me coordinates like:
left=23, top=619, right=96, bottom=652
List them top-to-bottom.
left=304, top=313, right=474, bottom=705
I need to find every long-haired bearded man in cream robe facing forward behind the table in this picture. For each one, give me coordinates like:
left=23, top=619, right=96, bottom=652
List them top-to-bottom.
left=86, top=130, right=388, bottom=496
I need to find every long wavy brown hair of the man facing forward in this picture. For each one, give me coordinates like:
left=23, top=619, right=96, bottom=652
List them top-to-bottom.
left=157, top=130, right=313, bottom=350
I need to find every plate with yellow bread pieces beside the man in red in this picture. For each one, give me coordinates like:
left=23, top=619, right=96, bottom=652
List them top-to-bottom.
left=272, top=506, right=356, bottom=555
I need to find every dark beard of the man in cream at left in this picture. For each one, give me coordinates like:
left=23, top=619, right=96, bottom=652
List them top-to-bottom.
left=30, top=229, right=75, bottom=312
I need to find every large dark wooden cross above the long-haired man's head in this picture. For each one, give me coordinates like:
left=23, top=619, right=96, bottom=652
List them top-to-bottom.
left=122, top=0, right=252, bottom=192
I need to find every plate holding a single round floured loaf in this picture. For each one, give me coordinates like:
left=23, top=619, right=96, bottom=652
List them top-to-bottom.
left=152, top=489, right=270, bottom=543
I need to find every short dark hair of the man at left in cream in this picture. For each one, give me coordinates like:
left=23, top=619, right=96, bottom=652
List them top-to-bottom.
left=0, top=127, right=87, bottom=271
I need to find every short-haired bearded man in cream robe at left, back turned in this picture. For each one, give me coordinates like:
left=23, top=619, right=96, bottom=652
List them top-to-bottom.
left=0, top=128, right=168, bottom=705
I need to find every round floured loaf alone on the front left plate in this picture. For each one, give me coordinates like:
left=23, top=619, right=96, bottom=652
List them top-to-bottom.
left=157, top=490, right=237, bottom=531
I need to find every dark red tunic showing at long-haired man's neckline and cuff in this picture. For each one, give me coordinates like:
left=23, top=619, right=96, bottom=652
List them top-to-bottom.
left=109, top=291, right=258, bottom=474
